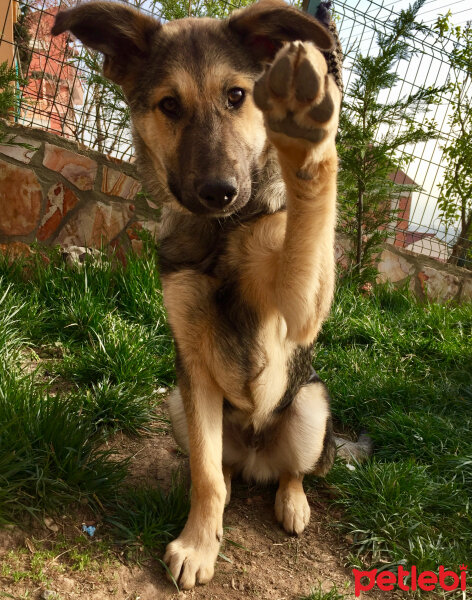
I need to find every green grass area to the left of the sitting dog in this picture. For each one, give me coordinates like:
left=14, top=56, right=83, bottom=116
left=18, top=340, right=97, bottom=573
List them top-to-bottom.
left=0, top=245, right=174, bottom=523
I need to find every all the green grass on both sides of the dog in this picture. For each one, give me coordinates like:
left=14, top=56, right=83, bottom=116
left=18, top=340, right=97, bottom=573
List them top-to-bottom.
left=0, top=240, right=472, bottom=600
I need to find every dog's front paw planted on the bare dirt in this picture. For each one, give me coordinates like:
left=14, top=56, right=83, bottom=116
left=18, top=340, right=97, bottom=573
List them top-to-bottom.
left=164, top=535, right=220, bottom=590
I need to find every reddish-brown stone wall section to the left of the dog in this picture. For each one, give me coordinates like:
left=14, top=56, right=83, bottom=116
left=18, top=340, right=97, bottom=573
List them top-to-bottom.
left=0, top=127, right=159, bottom=252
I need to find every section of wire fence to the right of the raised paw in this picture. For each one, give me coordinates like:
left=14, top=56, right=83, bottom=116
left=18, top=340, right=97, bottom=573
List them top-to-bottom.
left=335, top=0, right=472, bottom=268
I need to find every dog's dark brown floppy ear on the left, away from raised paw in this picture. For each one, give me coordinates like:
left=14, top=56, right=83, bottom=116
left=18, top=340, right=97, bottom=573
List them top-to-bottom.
left=51, top=2, right=161, bottom=85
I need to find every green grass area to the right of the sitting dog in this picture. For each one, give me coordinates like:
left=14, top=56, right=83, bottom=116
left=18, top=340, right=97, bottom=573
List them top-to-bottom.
left=314, top=287, right=472, bottom=571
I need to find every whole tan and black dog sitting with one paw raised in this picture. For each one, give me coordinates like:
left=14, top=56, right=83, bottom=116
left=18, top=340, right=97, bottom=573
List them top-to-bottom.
left=53, top=0, right=340, bottom=588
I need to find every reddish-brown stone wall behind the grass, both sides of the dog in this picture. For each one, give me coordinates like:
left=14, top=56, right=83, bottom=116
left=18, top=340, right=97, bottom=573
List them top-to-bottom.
left=0, top=127, right=472, bottom=301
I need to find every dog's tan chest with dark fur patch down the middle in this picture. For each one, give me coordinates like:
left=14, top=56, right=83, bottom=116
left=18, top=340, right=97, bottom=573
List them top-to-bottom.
left=162, top=214, right=295, bottom=421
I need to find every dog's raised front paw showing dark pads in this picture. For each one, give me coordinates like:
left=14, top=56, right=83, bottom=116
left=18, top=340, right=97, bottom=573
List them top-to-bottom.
left=254, top=42, right=341, bottom=144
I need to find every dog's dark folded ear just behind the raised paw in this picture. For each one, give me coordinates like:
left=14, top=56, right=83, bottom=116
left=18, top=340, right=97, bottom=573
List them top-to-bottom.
left=228, top=0, right=334, bottom=60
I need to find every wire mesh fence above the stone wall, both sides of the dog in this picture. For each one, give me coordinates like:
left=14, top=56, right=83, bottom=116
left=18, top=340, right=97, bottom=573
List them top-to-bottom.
left=0, top=0, right=472, bottom=266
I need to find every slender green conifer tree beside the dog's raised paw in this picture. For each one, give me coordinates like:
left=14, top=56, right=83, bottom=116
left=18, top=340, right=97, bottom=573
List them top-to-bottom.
left=338, top=0, right=439, bottom=281
